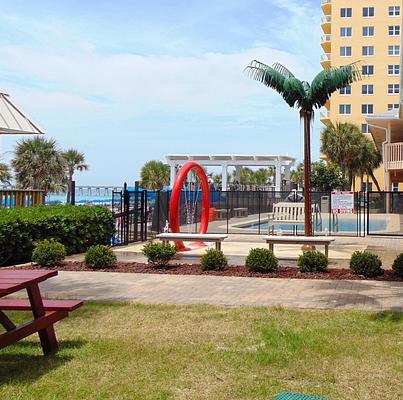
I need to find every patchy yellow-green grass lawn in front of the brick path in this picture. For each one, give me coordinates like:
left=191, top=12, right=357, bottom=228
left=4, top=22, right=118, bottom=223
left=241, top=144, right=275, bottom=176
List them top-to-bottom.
left=0, top=303, right=403, bottom=400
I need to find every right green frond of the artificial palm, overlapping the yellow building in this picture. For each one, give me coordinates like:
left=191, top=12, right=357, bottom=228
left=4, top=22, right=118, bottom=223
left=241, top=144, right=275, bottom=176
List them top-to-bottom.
left=309, top=62, right=361, bottom=108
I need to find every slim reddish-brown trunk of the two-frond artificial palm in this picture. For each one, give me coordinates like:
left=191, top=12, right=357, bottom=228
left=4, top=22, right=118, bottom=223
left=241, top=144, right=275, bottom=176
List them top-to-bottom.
left=300, top=110, right=313, bottom=236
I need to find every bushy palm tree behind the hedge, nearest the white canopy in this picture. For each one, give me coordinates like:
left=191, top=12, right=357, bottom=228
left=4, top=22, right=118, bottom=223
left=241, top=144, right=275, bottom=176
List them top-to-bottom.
left=11, top=136, right=66, bottom=191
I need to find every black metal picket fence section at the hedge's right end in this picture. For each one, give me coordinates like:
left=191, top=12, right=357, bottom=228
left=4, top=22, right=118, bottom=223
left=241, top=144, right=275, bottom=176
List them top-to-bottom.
left=112, top=184, right=148, bottom=246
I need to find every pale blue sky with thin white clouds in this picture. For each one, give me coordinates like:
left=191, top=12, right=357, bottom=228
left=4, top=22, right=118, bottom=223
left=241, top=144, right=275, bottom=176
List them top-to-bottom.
left=0, top=0, right=321, bottom=185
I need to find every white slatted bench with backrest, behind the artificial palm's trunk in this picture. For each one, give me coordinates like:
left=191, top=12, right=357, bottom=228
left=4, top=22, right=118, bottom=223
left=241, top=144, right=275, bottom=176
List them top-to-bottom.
left=268, top=202, right=320, bottom=233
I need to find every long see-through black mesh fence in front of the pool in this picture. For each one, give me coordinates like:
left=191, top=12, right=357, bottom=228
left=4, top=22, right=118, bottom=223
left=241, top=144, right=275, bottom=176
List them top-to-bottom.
left=148, top=191, right=366, bottom=236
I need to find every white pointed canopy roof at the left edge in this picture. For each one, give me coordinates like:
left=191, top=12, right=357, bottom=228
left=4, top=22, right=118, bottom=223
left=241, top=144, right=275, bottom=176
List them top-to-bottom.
left=0, top=92, right=45, bottom=135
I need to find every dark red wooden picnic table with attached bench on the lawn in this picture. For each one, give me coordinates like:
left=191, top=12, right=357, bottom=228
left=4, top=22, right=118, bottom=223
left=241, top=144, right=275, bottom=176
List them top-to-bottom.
left=0, top=270, right=83, bottom=354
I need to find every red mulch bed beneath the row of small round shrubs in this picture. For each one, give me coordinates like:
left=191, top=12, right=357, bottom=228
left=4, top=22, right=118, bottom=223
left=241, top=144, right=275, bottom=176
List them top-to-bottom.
left=12, top=261, right=403, bottom=282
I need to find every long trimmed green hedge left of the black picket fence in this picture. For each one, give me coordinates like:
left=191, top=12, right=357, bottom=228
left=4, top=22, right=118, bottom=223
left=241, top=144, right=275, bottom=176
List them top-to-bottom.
left=0, top=205, right=114, bottom=266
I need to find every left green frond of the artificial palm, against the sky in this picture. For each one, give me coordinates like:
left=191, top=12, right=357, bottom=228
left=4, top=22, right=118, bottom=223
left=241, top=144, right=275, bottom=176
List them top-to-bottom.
left=246, top=60, right=306, bottom=107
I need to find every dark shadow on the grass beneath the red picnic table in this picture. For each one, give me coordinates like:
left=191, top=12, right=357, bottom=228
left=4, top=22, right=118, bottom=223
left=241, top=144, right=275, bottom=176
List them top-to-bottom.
left=0, top=340, right=85, bottom=386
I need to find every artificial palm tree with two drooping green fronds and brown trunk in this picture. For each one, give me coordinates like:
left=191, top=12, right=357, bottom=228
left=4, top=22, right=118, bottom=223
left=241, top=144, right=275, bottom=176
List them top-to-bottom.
left=247, top=60, right=361, bottom=236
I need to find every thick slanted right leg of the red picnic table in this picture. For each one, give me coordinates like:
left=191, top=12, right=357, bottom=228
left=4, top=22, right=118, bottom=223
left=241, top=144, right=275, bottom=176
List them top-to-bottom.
left=27, top=285, right=59, bottom=355
